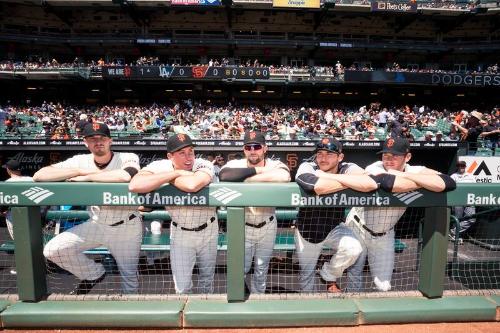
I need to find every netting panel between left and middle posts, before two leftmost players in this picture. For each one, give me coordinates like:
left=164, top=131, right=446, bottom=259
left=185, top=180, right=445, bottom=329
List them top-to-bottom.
left=44, top=207, right=226, bottom=294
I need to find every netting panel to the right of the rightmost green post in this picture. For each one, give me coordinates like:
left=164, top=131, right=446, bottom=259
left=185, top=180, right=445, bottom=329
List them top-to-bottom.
left=444, top=206, right=500, bottom=294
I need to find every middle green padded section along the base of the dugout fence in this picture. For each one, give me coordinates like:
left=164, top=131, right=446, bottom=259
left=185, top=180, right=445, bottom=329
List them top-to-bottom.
left=184, top=299, right=358, bottom=328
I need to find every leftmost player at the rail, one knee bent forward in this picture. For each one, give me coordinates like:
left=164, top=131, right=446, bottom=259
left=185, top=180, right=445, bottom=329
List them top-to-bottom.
left=33, top=123, right=142, bottom=295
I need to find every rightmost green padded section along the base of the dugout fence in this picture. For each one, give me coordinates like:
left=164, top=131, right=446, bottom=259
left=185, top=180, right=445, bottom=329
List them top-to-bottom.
left=357, top=296, right=496, bottom=324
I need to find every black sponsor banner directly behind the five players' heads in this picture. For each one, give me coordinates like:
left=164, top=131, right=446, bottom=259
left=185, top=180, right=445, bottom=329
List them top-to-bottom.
left=0, top=138, right=460, bottom=180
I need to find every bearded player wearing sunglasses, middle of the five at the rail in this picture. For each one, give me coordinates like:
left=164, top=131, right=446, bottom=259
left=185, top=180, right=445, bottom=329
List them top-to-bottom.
left=219, top=131, right=290, bottom=294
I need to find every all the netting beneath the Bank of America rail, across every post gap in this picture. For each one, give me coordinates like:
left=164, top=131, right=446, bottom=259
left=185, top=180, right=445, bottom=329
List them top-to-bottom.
left=0, top=207, right=500, bottom=297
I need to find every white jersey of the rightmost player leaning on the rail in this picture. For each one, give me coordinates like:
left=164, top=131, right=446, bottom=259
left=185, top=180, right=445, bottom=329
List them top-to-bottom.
left=349, top=161, right=425, bottom=233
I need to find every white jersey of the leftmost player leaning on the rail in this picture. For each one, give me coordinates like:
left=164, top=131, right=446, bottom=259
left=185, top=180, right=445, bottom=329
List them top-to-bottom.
left=52, top=152, right=140, bottom=225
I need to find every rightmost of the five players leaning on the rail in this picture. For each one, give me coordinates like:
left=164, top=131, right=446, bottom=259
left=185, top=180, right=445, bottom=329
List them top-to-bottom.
left=346, top=138, right=456, bottom=292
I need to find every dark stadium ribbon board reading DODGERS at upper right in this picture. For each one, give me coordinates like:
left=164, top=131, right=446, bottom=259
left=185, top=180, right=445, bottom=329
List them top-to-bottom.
left=344, top=70, right=500, bottom=87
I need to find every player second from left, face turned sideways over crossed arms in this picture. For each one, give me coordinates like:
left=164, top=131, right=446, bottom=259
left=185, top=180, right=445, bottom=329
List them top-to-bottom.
left=129, top=134, right=219, bottom=294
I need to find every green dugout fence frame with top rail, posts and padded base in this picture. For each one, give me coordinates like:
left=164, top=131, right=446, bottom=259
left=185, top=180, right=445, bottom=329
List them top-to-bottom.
left=0, top=183, right=500, bottom=327
